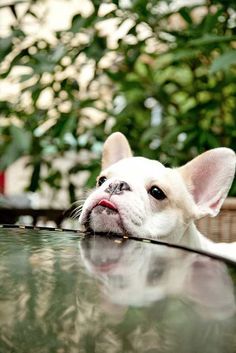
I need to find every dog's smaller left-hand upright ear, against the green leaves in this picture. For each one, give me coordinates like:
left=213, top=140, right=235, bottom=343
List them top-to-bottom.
left=102, top=132, right=132, bottom=169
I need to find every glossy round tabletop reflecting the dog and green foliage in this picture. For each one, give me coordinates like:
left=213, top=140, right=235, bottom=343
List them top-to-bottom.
left=0, top=229, right=236, bottom=353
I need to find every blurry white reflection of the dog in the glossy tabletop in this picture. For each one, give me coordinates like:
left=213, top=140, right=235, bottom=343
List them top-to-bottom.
left=81, top=236, right=236, bottom=319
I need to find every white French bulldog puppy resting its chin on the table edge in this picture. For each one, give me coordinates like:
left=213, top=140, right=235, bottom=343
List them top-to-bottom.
left=79, top=132, right=236, bottom=260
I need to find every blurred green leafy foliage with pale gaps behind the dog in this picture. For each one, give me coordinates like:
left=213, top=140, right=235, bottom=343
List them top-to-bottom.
left=0, top=0, right=236, bottom=223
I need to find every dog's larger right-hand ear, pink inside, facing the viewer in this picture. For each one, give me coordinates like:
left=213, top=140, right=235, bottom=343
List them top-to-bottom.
left=178, top=147, right=236, bottom=218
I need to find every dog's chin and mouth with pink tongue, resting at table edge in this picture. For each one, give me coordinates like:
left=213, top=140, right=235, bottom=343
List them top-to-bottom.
left=87, top=205, right=125, bottom=234
